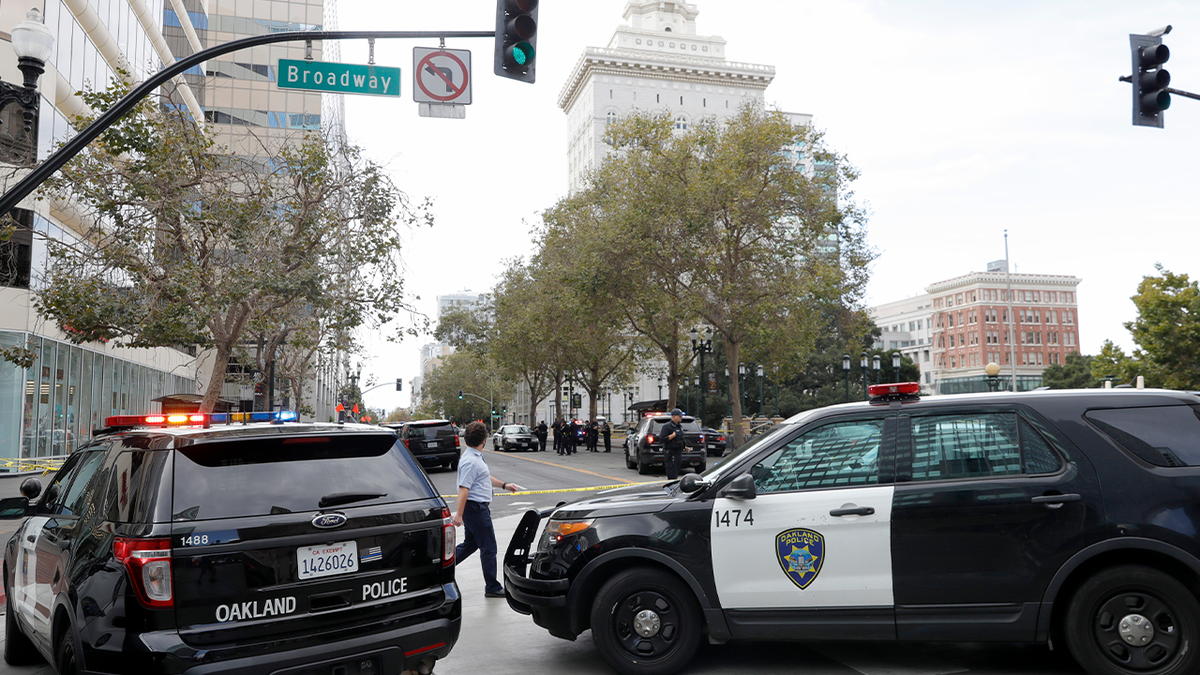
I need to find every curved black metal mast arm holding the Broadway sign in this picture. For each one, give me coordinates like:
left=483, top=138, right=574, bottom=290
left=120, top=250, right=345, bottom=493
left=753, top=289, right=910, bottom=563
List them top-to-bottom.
left=0, top=30, right=496, bottom=214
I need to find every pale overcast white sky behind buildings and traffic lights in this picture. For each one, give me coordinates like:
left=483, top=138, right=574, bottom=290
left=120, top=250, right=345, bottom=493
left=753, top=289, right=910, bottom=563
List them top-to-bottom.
left=340, top=0, right=1200, bottom=410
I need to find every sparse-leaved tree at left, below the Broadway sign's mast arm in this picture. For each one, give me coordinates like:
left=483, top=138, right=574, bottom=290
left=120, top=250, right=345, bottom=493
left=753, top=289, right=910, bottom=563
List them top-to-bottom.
left=36, top=84, right=427, bottom=412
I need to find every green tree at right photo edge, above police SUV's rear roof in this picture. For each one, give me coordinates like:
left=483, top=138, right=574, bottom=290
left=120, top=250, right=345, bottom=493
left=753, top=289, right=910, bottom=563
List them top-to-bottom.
left=1124, top=264, right=1200, bottom=389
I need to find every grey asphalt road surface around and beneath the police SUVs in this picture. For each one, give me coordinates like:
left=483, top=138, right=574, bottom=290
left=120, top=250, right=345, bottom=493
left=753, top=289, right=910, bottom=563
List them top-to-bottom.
left=0, top=444, right=1082, bottom=675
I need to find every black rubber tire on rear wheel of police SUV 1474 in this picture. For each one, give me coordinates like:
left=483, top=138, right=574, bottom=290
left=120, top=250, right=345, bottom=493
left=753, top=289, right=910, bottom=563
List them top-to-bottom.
left=1064, top=565, right=1200, bottom=675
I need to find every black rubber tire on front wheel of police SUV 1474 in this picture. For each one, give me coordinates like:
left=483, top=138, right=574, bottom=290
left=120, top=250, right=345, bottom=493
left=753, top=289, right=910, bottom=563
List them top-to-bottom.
left=592, top=567, right=701, bottom=675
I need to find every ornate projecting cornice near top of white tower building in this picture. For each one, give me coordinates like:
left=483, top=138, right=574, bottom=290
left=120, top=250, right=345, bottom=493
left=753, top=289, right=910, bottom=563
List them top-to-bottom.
left=558, top=47, right=775, bottom=110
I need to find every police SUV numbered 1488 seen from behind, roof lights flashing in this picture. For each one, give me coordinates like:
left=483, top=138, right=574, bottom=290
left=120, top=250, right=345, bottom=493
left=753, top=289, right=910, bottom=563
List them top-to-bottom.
left=0, top=413, right=462, bottom=675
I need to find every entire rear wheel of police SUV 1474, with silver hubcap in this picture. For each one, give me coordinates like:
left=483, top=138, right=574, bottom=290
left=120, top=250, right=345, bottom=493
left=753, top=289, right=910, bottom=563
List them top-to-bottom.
left=1066, top=565, right=1200, bottom=675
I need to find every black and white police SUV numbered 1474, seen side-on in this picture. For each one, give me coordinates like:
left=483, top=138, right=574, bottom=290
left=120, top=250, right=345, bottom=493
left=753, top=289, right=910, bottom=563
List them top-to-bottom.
left=504, top=383, right=1200, bottom=675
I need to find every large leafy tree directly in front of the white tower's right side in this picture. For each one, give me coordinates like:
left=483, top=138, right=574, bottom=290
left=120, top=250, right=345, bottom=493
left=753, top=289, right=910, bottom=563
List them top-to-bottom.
left=606, top=103, right=872, bottom=440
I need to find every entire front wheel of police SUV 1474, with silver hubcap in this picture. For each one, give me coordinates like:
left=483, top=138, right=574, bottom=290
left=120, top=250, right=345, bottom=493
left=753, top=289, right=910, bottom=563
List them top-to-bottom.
left=592, top=568, right=701, bottom=675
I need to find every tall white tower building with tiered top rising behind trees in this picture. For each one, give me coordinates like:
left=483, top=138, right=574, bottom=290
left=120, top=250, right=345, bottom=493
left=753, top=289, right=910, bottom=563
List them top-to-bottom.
left=558, top=0, right=775, bottom=192
